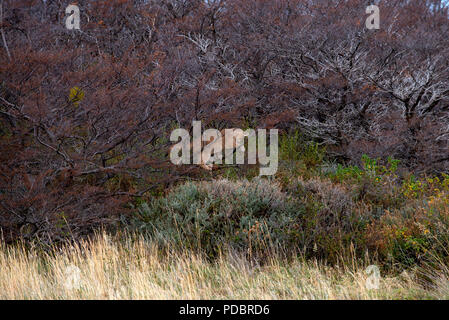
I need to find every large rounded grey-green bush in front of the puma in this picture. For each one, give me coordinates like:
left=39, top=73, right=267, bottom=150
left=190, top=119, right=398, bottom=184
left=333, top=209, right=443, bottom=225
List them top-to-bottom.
left=134, top=178, right=301, bottom=256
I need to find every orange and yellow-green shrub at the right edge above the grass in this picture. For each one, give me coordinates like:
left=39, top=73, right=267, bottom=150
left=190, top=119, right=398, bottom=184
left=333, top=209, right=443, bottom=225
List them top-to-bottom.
left=366, top=192, right=449, bottom=268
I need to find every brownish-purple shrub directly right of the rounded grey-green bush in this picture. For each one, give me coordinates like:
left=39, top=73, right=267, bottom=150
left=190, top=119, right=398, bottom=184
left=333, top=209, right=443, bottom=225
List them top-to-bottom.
left=288, top=177, right=372, bottom=262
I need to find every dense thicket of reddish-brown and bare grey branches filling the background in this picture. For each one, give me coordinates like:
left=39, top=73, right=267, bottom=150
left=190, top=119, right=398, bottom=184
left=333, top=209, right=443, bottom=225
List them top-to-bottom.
left=0, top=0, right=449, bottom=239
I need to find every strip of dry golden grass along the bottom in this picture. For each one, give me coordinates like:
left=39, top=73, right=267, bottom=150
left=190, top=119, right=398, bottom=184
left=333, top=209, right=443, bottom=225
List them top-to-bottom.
left=0, top=235, right=449, bottom=299
